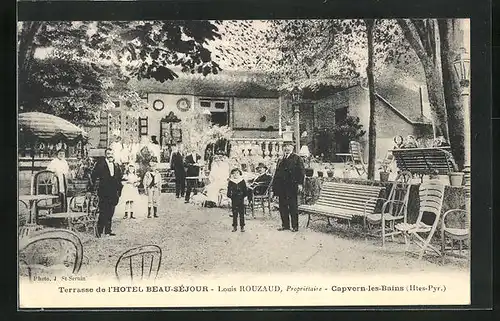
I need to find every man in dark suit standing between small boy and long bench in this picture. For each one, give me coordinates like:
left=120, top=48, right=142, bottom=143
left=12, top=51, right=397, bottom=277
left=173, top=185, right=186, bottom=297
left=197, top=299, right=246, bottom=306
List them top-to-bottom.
left=273, top=142, right=305, bottom=232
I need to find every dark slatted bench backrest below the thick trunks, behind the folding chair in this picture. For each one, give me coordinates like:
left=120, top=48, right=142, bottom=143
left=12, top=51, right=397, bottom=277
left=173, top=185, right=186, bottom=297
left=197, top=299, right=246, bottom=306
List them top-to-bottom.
left=391, top=148, right=458, bottom=175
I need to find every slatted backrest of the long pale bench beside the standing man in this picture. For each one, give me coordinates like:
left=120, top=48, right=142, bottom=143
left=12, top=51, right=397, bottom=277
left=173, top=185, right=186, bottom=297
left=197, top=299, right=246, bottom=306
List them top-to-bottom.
left=315, top=182, right=385, bottom=213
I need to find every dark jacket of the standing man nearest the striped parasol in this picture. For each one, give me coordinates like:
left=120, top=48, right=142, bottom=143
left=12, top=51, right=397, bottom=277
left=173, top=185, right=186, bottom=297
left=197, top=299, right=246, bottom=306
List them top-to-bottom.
left=91, top=159, right=123, bottom=205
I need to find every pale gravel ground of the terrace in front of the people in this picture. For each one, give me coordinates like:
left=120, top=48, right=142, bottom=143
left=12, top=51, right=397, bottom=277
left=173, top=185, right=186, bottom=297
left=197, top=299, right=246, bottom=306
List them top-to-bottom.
left=81, top=194, right=469, bottom=278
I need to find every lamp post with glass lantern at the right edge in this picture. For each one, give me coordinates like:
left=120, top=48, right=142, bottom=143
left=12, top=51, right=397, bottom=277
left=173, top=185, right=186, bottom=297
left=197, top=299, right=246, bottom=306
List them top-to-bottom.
left=453, top=48, right=471, bottom=240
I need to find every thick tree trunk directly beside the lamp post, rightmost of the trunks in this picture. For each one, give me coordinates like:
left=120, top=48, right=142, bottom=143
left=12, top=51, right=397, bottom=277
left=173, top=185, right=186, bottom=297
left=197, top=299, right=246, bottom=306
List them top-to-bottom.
left=439, top=19, right=467, bottom=169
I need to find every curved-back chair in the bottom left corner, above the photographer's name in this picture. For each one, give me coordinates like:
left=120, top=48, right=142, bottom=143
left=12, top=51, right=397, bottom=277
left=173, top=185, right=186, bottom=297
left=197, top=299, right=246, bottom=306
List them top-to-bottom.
left=19, top=229, right=83, bottom=281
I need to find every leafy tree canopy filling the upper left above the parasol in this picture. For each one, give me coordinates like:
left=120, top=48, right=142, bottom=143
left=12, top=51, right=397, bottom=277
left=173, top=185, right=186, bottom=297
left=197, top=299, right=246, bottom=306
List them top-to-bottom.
left=18, top=21, right=220, bottom=123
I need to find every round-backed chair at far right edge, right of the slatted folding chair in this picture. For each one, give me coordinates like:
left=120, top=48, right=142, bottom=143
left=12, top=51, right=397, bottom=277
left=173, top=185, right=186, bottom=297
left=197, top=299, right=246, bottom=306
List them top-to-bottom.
left=441, top=209, right=470, bottom=263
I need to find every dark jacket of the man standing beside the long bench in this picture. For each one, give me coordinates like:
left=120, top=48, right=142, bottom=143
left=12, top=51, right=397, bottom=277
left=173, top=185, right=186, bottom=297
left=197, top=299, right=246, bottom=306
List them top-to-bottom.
left=273, top=153, right=305, bottom=195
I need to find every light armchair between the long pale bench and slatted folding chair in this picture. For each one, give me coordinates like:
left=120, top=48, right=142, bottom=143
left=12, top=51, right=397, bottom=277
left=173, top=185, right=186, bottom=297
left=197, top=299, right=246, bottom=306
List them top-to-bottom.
left=364, top=171, right=412, bottom=246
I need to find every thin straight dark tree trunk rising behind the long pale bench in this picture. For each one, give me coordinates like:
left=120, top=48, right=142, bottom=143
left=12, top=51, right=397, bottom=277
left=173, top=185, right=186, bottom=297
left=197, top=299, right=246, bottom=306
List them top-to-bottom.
left=365, top=19, right=377, bottom=180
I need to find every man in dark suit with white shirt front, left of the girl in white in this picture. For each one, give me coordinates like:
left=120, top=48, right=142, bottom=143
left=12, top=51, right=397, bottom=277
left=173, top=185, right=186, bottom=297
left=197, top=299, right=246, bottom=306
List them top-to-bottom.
left=92, top=148, right=122, bottom=237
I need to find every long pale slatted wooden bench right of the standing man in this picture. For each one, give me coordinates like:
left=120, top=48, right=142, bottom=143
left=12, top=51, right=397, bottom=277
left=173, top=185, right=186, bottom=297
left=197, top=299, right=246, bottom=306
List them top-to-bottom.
left=299, top=182, right=385, bottom=227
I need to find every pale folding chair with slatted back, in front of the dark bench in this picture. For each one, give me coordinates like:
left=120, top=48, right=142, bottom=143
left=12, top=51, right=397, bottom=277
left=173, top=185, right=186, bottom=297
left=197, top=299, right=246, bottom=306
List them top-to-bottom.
left=395, top=180, right=444, bottom=260
